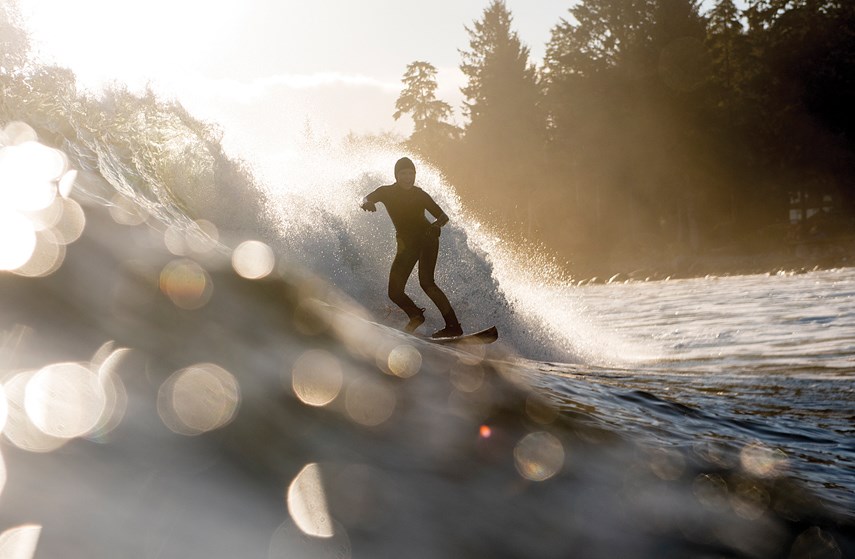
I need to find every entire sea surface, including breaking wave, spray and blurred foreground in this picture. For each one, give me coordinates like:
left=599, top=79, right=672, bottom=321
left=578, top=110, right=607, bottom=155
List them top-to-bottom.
left=0, top=114, right=855, bottom=559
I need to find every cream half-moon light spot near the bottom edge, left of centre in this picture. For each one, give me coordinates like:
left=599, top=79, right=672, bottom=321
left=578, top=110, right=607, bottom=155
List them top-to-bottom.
left=288, top=464, right=335, bottom=538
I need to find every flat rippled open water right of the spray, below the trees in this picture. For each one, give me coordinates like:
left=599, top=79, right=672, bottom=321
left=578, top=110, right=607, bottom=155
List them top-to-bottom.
left=533, top=268, right=855, bottom=512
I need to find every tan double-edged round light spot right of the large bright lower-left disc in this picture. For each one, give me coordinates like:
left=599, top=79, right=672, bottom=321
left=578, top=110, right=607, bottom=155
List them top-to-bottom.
left=157, top=363, right=240, bottom=436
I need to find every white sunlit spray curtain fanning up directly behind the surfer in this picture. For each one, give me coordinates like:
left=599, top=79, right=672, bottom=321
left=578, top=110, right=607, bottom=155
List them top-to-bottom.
left=204, top=136, right=644, bottom=363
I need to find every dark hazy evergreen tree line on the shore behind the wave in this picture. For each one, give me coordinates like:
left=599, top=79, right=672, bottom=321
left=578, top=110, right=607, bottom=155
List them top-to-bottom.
left=394, top=0, right=855, bottom=274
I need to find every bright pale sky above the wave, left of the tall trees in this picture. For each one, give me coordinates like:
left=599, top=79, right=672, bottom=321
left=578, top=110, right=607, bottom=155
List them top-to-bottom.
left=18, top=0, right=573, bottom=143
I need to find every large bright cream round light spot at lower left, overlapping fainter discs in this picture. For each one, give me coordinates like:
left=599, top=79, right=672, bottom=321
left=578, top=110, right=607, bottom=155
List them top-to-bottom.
left=24, top=363, right=106, bottom=439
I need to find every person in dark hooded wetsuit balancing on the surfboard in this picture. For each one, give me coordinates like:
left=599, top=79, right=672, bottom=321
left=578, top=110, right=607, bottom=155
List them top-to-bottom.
left=362, top=157, right=463, bottom=338
